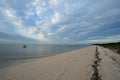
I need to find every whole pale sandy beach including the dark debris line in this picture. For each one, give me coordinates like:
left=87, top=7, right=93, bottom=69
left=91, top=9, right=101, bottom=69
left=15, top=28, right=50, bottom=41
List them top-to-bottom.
left=0, top=46, right=120, bottom=80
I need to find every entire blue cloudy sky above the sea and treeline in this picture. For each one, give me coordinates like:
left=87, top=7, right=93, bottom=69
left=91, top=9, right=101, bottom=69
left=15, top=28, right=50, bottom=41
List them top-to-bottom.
left=0, top=0, right=120, bottom=44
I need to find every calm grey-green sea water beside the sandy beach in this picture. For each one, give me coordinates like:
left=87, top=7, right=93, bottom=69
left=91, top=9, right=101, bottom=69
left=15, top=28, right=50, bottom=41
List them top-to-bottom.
left=0, top=44, right=88, bottom=68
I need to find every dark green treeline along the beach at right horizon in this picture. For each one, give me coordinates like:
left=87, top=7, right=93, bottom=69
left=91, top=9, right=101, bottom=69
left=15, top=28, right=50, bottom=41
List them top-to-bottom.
left=94, top=42, right=120, bottom=54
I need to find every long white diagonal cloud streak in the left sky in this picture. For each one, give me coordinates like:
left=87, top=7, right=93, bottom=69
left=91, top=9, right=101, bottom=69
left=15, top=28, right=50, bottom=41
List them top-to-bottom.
left=2, top=8, right=36, bottom=35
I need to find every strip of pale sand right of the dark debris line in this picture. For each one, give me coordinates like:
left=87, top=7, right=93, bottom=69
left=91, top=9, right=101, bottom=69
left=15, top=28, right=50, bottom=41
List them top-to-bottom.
left=98, top=47, right=120, bottom=80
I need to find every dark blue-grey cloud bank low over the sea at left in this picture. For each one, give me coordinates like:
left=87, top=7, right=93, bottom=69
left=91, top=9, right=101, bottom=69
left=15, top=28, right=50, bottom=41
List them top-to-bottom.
left=0, top=32, right=39, bottom=44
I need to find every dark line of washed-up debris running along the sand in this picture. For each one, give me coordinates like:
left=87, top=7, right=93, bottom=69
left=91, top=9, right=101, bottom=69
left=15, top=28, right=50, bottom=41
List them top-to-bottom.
left=90, top=47, right=101, bottom=80
